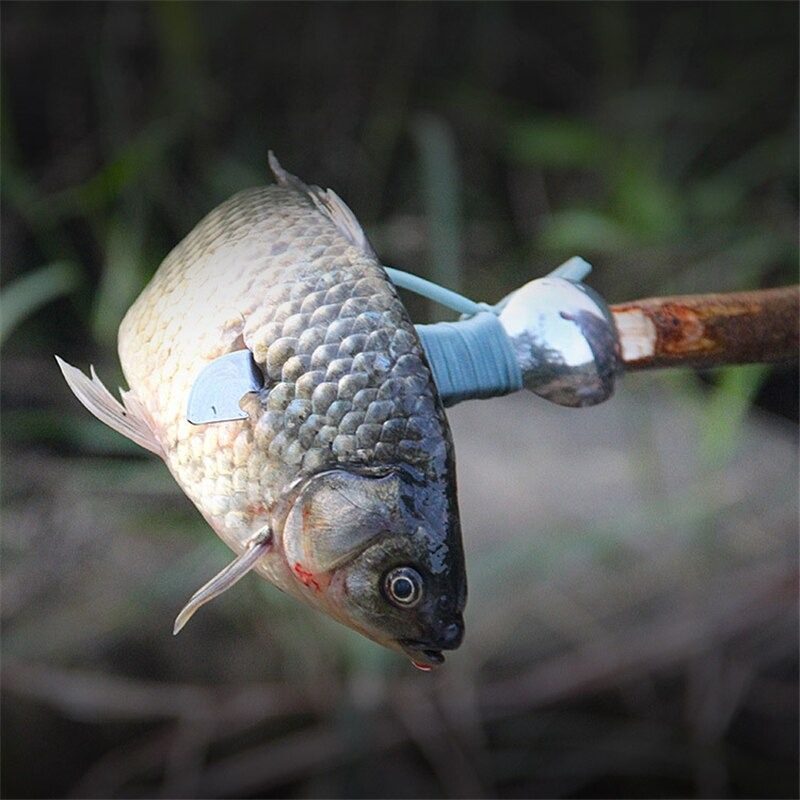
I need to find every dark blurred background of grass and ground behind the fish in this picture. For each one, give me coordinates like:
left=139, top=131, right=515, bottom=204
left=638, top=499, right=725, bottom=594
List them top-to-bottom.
left=0, top=2, right=798, bottom=797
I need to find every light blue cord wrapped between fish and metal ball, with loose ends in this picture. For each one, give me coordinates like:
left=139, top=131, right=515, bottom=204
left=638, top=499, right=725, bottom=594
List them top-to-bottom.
left=385, top=256, right=592, bottom=406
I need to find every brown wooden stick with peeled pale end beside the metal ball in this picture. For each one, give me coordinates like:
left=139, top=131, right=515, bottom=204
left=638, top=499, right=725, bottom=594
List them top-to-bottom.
left=611, top=286, right=800, bottom=371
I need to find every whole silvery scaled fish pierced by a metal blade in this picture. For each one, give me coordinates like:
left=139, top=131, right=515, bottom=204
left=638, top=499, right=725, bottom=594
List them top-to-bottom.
left=56, top=152, right=467, bottom=670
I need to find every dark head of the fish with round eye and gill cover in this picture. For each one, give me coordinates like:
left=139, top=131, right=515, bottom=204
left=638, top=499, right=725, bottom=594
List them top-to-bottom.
left=281, top=467, right=466, bottom=669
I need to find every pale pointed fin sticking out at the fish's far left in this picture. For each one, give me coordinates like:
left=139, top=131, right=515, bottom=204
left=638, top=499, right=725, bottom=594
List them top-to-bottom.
left=56, top=356, right=164, bottom=458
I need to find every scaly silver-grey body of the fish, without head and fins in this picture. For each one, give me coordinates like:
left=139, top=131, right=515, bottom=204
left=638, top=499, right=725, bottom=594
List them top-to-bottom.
left=119, top=177, right=450, bottom=579
